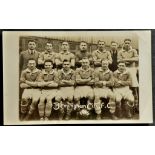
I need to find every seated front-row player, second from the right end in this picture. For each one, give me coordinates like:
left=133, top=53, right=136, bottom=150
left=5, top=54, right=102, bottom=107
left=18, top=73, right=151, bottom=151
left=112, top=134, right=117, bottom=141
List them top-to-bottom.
left=94, top=60, right=117, bottom=119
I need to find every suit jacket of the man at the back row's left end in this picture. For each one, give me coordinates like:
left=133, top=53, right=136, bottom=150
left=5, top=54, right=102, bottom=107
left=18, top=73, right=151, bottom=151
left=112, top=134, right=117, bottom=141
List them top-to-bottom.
left=20, top=50, right=39, bottom=70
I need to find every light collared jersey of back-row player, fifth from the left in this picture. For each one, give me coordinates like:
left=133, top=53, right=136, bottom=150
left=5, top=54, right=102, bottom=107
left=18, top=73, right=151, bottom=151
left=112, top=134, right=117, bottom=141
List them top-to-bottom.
left=92, top=49, right=112, bottom=63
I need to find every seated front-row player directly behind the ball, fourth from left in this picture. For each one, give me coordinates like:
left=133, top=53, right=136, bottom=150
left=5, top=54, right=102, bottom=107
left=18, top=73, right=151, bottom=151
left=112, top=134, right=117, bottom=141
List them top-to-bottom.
left=74, top=58, right=94, bottom=119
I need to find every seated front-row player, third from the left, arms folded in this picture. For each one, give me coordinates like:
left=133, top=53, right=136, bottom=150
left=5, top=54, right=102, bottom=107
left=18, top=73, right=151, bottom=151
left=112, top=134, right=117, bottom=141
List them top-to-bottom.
left=55, top=60, right=75, bottom=120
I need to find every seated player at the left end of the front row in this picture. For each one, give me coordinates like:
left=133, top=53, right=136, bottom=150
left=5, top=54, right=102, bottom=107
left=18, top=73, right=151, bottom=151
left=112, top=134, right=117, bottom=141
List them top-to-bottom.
left=20, top=59, right=41, bottom=120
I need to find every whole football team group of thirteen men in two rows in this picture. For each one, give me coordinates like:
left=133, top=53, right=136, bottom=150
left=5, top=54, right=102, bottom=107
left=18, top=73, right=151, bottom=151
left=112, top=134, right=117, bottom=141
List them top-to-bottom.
left=19, top=39, right=139, bottom=120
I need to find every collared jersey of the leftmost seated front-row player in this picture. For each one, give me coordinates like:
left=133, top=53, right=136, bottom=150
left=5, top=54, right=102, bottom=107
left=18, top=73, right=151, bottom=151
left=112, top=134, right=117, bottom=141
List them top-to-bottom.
left=20, top=68, right=41, bottom=82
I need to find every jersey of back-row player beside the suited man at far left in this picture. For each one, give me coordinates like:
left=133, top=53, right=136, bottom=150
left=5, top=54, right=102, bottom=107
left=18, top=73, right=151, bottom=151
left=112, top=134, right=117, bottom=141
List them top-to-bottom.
left=39, top=51, right=56, bottom=63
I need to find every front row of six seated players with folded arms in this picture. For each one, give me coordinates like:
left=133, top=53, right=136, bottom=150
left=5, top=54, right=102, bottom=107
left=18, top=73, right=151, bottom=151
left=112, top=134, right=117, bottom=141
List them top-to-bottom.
left=20, top=58, right=134, bottom=120
